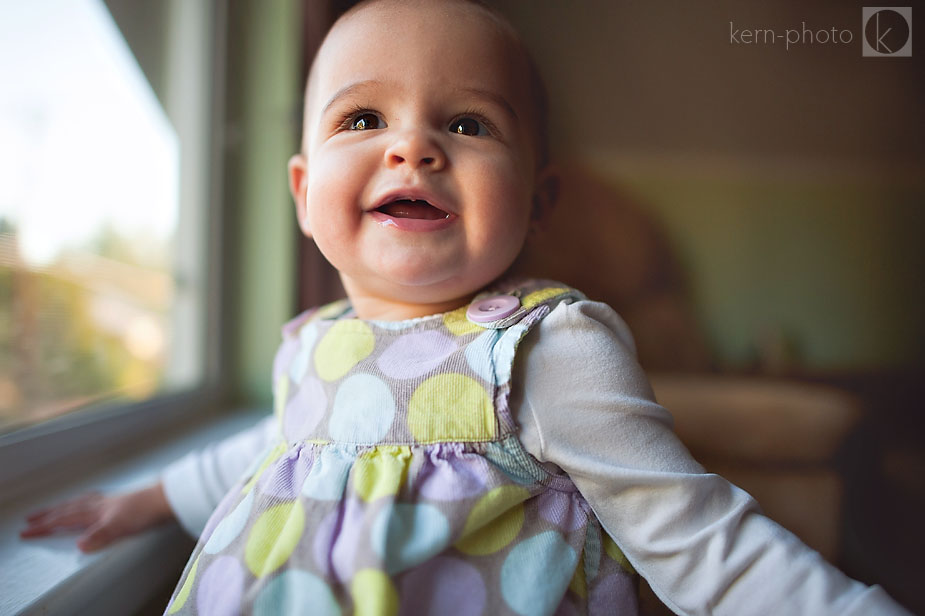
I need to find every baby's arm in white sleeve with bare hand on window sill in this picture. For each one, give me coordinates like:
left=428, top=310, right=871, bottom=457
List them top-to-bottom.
left=19, top=417, right=276, bottom=552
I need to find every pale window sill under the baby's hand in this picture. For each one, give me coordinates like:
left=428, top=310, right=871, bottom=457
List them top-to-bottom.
left=0, top=409, right=268, bottom=616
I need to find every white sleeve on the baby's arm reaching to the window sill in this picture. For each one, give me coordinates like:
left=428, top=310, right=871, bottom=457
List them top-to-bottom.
left=161, top=415, right=279, bottom=537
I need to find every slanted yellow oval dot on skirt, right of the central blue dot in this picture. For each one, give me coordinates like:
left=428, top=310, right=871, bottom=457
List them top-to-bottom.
left=456, top=486, right=530, bottom=556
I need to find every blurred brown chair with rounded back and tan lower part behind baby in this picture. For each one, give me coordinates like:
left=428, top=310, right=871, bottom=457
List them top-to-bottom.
left=515, top=168, right=862, bottom=614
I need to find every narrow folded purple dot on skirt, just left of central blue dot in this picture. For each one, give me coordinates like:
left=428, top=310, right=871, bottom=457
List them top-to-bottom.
left=312, top=499, right=363, bottom=581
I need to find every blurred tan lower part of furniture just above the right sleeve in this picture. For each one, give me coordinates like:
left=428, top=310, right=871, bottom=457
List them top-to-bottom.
left=650, top=372, right=862, bottom=562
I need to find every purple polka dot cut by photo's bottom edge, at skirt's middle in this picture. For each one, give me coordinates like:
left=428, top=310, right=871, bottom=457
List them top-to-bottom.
left=399, top=556, right=485, bottom=616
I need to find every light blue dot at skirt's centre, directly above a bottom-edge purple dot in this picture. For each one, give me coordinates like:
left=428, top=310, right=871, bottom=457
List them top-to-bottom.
left=370, top=503, right=450, bottom=573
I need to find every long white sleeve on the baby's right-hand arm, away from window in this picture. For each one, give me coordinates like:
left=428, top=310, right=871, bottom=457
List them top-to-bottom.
left=511, top=301, right=908, bottom=616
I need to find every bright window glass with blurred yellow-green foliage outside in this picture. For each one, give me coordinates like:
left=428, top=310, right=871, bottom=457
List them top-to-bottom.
left=0, top=0, right=221, bottom=476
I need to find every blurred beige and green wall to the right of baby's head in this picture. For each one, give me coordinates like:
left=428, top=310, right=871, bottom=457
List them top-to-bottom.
left=497, top=0, right=925, bottom=372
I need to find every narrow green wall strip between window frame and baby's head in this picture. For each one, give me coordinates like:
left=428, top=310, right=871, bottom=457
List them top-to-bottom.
left=224, top=0, right=302, bottom=402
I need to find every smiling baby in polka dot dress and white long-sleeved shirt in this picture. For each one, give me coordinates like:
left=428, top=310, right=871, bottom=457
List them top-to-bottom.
left=24, top=0, right=905, bottom=615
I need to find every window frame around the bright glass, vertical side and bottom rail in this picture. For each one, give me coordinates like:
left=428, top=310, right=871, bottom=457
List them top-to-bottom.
left=0, top=0, right=231, bottom=500
